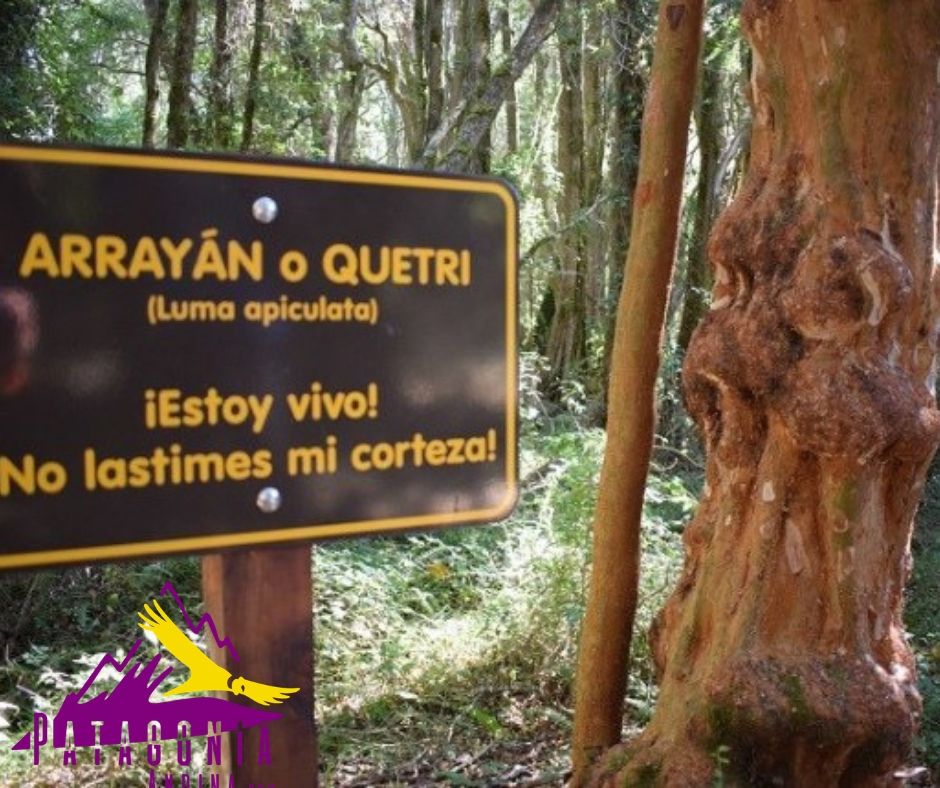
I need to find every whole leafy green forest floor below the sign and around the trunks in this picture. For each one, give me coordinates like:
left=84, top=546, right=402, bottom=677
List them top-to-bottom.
left=0, top=413, right=940, bottom=788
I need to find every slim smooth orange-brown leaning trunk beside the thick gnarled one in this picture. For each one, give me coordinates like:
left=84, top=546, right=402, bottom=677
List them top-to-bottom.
left=572, top=0, right=703, bottom=785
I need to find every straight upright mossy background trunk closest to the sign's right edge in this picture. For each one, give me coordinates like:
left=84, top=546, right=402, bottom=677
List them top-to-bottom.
left=545, top=4, right=586, bottom=396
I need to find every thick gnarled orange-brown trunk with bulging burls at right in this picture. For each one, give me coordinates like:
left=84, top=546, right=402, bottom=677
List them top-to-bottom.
left=596, top=0, right=940, bottom=788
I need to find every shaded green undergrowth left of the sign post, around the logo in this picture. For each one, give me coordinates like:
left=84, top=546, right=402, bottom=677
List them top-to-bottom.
left=0, top=558, right=202, bottom=788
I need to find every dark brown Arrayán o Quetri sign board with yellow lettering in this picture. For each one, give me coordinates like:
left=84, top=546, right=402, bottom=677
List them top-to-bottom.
left=0, top=146, right=517, bottom=569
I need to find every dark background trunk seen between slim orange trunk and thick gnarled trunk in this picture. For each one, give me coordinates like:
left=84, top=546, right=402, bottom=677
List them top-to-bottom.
left=677, top=38, right=722, bottom=352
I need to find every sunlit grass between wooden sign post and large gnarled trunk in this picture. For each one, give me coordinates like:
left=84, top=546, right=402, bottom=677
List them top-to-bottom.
left=316, top=418, right=694, bottom=785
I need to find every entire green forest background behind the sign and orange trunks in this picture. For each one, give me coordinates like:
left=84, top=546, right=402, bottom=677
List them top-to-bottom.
left=0, top=0, right=940, bottom=786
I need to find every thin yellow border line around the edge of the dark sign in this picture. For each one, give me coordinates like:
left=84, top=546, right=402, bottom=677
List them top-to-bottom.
left=0, top=145, right=518, bottom=569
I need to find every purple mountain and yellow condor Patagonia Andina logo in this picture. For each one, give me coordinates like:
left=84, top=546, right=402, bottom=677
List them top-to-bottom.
left=13, top=583, right=298, bottom=786
